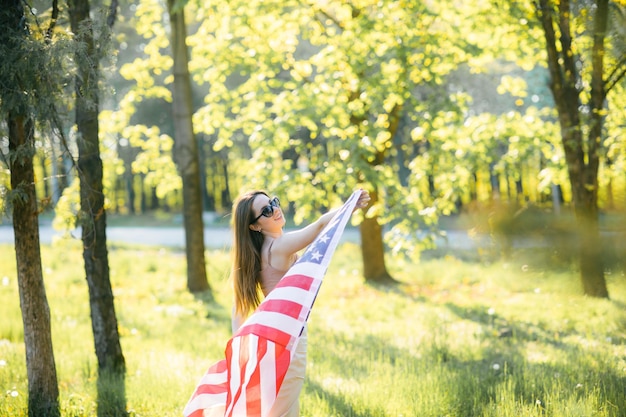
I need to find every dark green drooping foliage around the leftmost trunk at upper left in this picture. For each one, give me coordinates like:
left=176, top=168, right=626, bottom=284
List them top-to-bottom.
left=0, top=3, right=115, bottom=221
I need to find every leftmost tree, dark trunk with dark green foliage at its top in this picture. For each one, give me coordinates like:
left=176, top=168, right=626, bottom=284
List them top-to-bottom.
left=0, top=0, right=60, bottom=416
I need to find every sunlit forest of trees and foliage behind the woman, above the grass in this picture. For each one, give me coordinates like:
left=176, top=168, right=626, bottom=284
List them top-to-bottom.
left=0, top=0, right=626, bottom=414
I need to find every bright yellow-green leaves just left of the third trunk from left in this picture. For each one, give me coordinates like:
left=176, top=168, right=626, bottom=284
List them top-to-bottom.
left=105, top=1, right=182, bottom=210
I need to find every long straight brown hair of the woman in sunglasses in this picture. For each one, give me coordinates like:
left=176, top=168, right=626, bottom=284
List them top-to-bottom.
left=231, top=190, right=267, bottom=317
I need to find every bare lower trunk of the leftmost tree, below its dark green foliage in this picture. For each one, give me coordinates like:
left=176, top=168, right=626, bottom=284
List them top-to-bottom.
left=9, top=114, right=60, bottom=417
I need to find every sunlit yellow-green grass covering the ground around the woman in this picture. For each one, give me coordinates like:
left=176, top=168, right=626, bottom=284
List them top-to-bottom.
left=0, top=241, right=626, bottom=417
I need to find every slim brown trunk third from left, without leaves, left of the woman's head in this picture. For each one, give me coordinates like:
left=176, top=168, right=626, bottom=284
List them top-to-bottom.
left=167, top=0, right=210, bottom=292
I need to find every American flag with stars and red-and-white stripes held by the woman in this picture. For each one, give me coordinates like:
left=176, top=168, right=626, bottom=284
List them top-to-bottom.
left=183, top=191, right=360, bottom=417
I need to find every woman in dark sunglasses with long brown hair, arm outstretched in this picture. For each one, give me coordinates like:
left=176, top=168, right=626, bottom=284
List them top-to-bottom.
left=232, top=190, right=370, bottom=417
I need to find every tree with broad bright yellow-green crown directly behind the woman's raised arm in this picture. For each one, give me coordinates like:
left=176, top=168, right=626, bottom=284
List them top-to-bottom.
left=192, top=1, right=476, bottom=281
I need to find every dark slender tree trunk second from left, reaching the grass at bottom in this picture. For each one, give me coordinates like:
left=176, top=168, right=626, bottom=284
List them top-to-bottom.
left=69, top=0, right=126, bottom=416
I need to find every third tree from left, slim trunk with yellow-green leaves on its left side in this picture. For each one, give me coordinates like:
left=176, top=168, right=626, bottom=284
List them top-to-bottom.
left=109, top=1, right=210, bottom=292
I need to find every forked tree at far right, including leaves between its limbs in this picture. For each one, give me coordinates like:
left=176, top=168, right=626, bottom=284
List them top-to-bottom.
left=534, top=0, right=626, bottom=298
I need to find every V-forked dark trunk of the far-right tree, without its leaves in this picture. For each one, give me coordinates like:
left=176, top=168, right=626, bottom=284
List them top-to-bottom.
left=537, top=0, right=609, bottom=298
